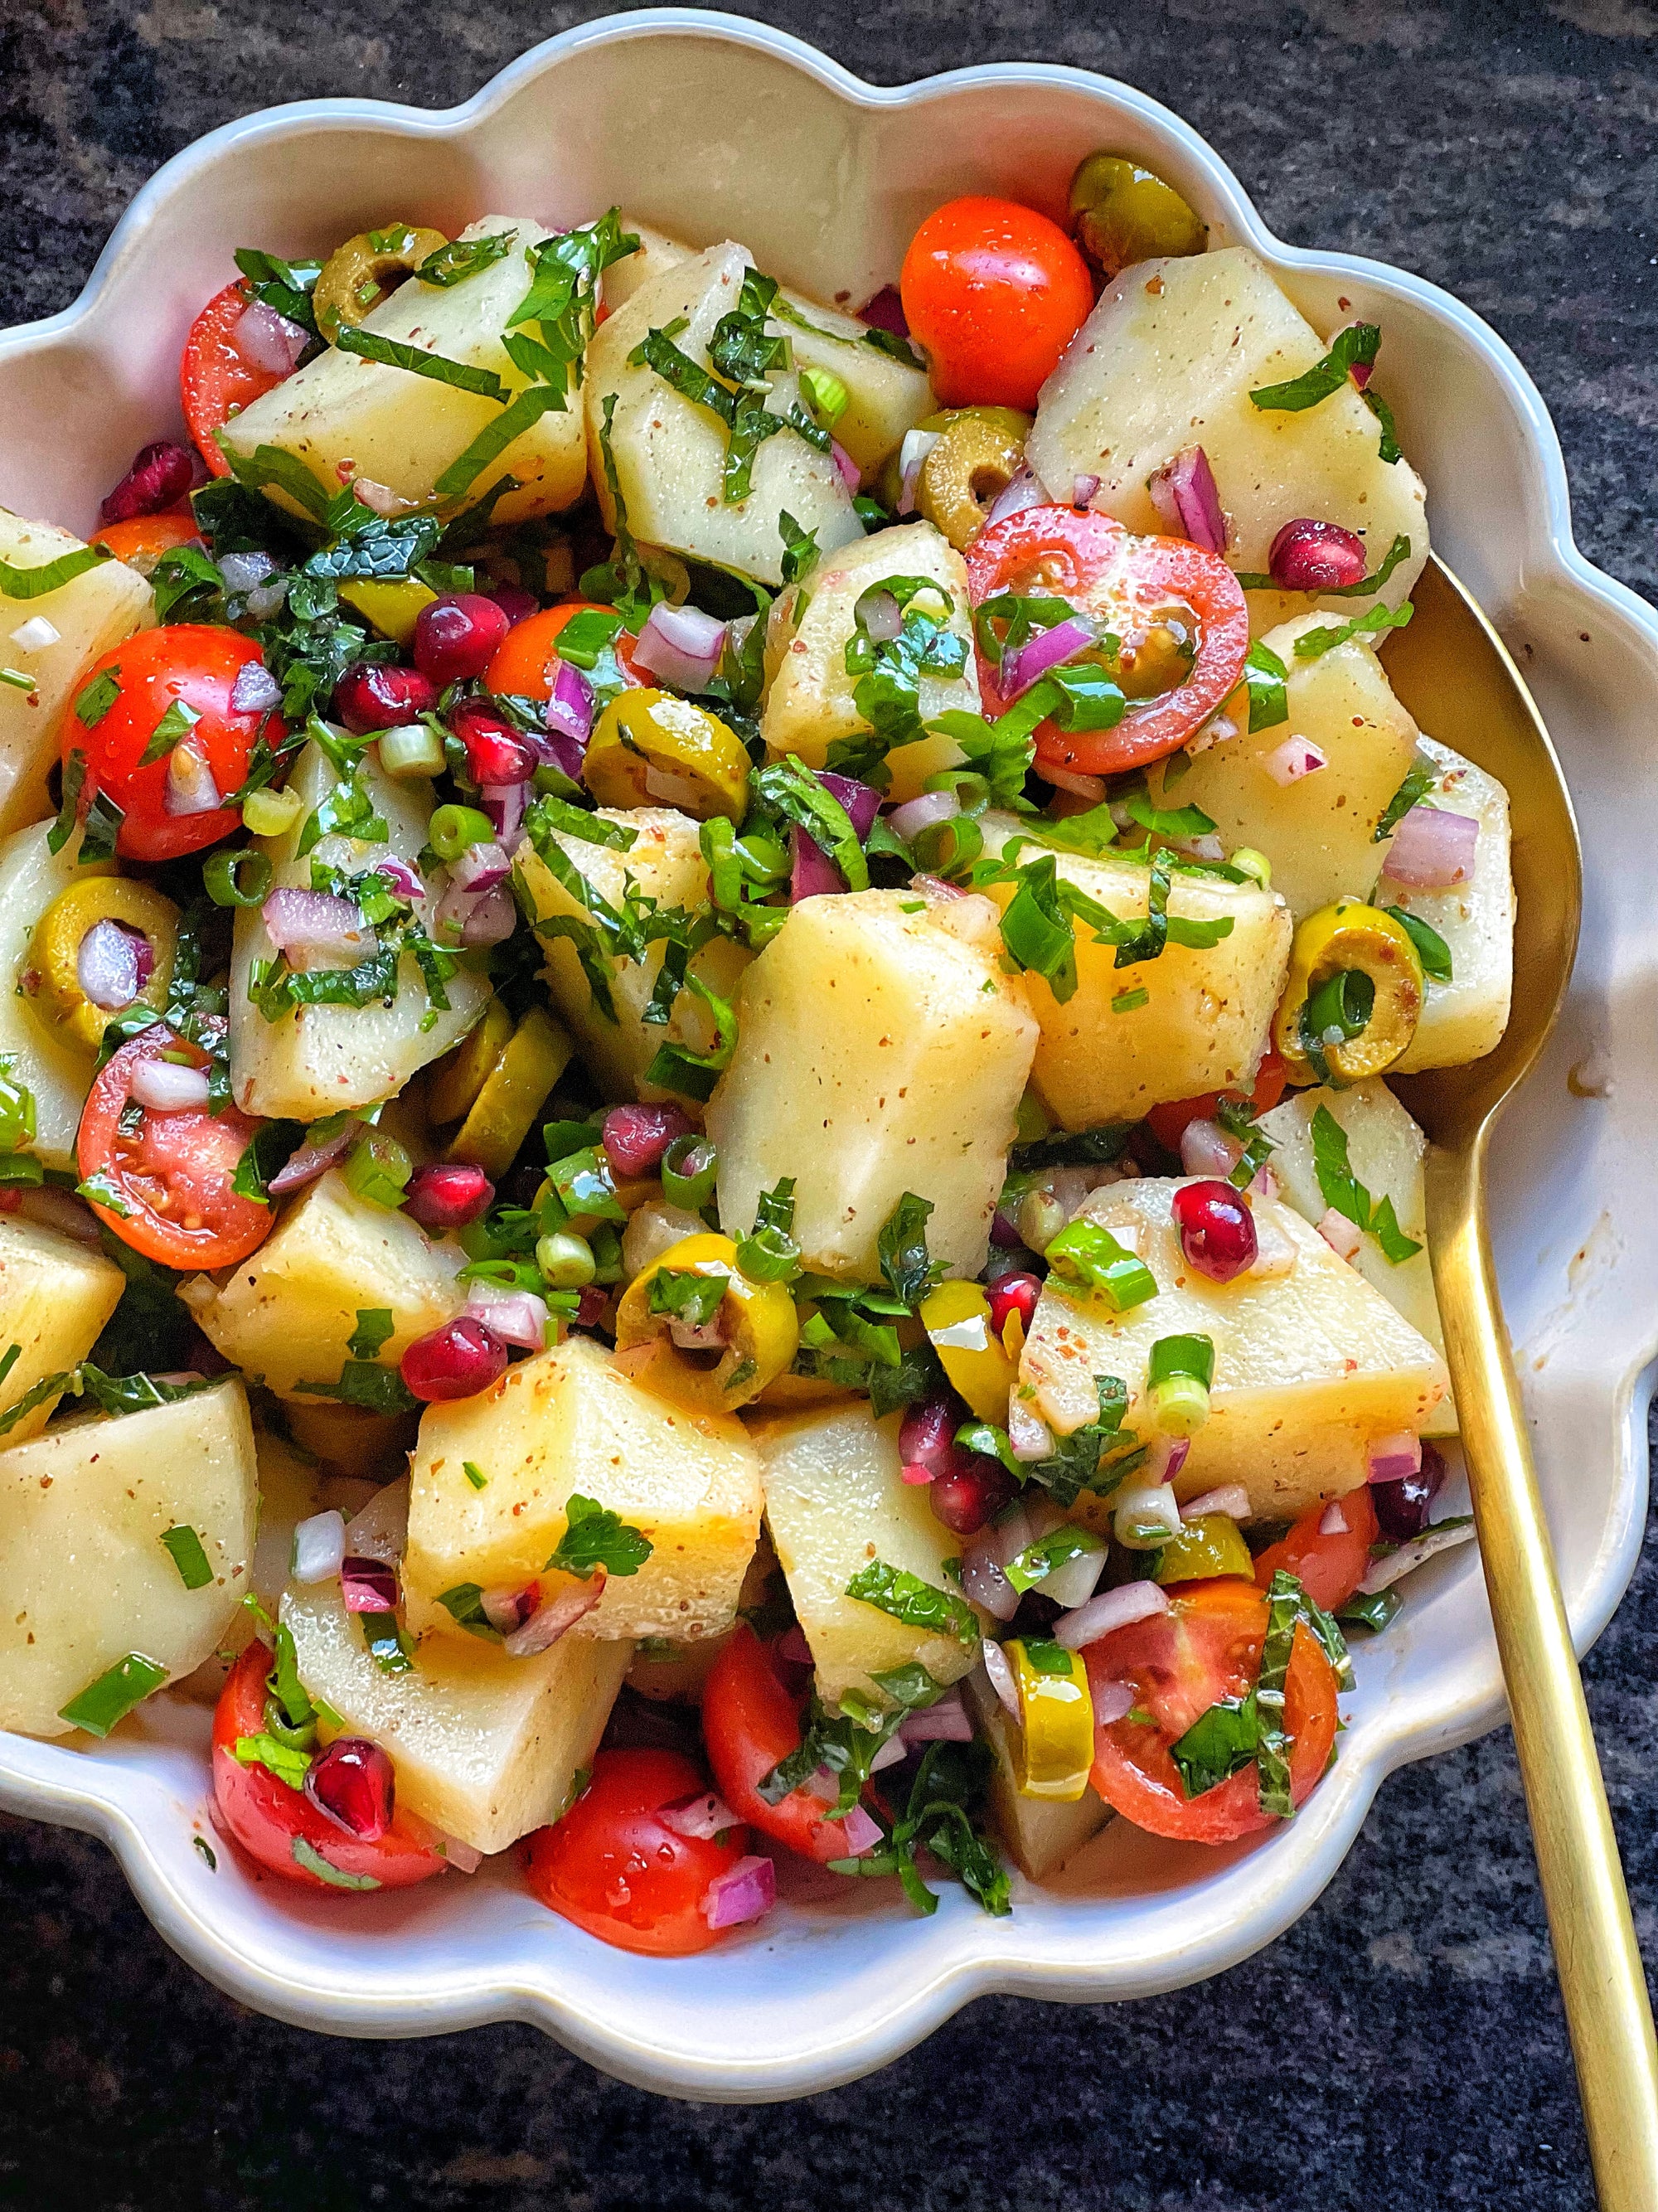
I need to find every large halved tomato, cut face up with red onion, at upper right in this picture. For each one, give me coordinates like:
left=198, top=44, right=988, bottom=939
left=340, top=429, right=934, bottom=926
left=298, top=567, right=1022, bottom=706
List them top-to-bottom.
left=966, top=507, right=1249, bottom=776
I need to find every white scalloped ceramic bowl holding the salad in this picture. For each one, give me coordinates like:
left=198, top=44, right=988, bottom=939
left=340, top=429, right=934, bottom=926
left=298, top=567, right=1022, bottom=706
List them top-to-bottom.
left=0, top=11, right=1658, bottom=2099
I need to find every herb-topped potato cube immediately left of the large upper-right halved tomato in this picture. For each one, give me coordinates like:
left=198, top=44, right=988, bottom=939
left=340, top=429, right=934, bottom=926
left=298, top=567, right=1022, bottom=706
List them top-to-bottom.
left=760, top=522, right=979, bottom=801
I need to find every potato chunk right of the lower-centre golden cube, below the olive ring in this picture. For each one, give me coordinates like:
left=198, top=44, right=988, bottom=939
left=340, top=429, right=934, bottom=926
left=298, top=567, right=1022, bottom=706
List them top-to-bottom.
left=754, top=1403, right=979, bottom=1703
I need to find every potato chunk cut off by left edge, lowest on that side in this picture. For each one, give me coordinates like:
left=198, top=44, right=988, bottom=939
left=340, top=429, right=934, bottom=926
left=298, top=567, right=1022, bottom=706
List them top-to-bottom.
left=0, top=1378, right=259, bottom=1736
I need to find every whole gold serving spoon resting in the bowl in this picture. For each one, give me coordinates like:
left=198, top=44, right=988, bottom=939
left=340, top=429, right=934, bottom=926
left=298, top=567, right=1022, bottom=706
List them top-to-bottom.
left=1386, top=557, right=1658, bottom=2212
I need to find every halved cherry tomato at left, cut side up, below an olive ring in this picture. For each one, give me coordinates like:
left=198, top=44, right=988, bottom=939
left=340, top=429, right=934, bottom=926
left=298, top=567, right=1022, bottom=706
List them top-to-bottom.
left=75, top=1022, right=274, bottom=1268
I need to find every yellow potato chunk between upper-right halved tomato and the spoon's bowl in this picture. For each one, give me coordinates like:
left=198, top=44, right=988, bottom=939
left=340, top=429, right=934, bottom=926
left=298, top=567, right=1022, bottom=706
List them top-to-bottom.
left=1147, top=615, right=1417, bottom=920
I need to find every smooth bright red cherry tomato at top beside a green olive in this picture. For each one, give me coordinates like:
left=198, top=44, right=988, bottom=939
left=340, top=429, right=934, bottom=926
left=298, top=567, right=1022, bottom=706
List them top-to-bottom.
left=899, top=196, right=1094, bottom=411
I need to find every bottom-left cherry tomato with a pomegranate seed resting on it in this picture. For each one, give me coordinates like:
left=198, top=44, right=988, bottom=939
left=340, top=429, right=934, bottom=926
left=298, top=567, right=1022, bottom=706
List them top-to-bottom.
left=212, top=1643, right=448, bottom=1895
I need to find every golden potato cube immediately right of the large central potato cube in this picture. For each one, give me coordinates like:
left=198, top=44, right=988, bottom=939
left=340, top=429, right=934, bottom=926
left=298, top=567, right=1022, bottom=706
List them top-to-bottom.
left=984, top=814, right=1293, bottom=1128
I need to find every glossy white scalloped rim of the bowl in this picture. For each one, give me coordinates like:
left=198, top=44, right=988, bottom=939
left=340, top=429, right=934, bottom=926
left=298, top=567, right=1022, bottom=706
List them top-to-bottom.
left=0, top=9, right=1658, bottom=2102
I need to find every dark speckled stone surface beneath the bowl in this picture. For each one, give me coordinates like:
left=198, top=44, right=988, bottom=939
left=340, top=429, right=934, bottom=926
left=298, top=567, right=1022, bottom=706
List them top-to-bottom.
left=0, top=0, right=1658, bottom=2212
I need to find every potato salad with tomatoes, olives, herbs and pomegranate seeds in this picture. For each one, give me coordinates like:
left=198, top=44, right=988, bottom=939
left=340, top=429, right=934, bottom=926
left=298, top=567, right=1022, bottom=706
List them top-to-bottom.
left=0, top=150, right=1515, bottom=1956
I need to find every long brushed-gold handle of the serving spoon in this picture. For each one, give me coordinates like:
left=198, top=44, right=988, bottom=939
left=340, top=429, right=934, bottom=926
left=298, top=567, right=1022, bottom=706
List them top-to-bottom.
left=1428, top=1130, right=1658, bottom=2212
